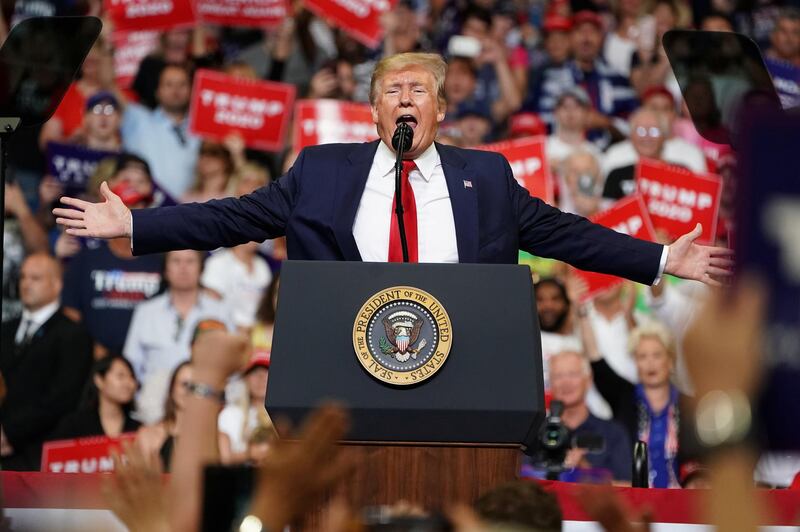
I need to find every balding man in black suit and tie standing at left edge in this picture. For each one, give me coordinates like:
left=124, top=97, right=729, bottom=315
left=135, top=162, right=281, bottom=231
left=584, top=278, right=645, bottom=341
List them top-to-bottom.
left=0, top=254, right=92, bottom=470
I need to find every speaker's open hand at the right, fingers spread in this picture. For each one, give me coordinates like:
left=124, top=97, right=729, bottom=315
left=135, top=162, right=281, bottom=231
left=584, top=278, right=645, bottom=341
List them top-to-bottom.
left=664, top=224, right=733, bottom=286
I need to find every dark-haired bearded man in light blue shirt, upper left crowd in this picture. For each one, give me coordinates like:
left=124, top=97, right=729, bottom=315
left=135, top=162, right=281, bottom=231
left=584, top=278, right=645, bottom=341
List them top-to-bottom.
left=122, top=65, right=200, bottom=198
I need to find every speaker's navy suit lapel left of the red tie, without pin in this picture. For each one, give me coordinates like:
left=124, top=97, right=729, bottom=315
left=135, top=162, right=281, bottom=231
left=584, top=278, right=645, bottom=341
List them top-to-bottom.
left=333, top=140, right=380, bottom=261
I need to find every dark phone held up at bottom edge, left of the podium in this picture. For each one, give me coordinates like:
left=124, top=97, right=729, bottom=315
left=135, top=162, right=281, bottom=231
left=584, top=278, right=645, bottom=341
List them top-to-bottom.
left=201, top=465, right=256, bottom=532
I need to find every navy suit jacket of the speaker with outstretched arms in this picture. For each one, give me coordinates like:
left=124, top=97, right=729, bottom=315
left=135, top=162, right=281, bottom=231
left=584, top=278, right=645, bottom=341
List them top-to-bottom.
left=133, top=141, right=663, bottom=284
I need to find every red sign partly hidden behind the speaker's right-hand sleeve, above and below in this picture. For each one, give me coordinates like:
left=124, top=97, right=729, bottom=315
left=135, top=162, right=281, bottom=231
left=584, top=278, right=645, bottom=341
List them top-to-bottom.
left=574, top=194, right=655, bottom=301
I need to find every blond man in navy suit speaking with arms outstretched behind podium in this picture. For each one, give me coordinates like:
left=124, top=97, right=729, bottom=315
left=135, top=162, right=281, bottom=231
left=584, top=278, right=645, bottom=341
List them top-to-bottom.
left=54, top=54, right=731, bottom=284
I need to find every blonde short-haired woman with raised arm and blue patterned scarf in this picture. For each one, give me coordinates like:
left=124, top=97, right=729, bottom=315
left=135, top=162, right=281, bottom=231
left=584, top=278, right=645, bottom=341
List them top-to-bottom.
left=581, top=318, right=691, bottom=488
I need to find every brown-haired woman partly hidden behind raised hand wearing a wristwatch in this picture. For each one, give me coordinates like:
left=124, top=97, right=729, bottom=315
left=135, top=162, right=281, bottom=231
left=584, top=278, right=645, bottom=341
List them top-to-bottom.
left=136, top=361, right=192, bottom=471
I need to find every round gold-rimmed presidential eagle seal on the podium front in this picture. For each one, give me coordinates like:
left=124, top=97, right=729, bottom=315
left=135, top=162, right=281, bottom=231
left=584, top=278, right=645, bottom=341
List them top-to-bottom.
left=353, top=286, right=453, bottom=386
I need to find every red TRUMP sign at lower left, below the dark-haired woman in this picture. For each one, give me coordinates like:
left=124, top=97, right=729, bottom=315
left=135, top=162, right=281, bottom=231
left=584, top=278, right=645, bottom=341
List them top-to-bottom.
left=42, top=432, right=136, bottom=473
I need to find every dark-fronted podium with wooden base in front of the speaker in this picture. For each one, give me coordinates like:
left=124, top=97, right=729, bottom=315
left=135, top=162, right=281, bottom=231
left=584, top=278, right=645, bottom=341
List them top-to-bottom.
left=266, top=261, right=544, bottom=530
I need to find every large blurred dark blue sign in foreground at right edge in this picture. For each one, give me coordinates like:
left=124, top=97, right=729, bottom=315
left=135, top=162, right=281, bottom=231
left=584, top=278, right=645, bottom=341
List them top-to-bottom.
left=736, top=104, right=800, bottom=450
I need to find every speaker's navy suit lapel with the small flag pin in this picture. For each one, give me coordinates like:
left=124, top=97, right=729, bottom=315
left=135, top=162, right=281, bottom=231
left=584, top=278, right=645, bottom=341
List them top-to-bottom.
left=436, top=143, right=478, bottom=262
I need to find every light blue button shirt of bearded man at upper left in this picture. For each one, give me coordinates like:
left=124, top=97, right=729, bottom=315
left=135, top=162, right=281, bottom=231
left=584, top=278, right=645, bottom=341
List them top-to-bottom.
left=121, top=103, right=200, bottom=198
